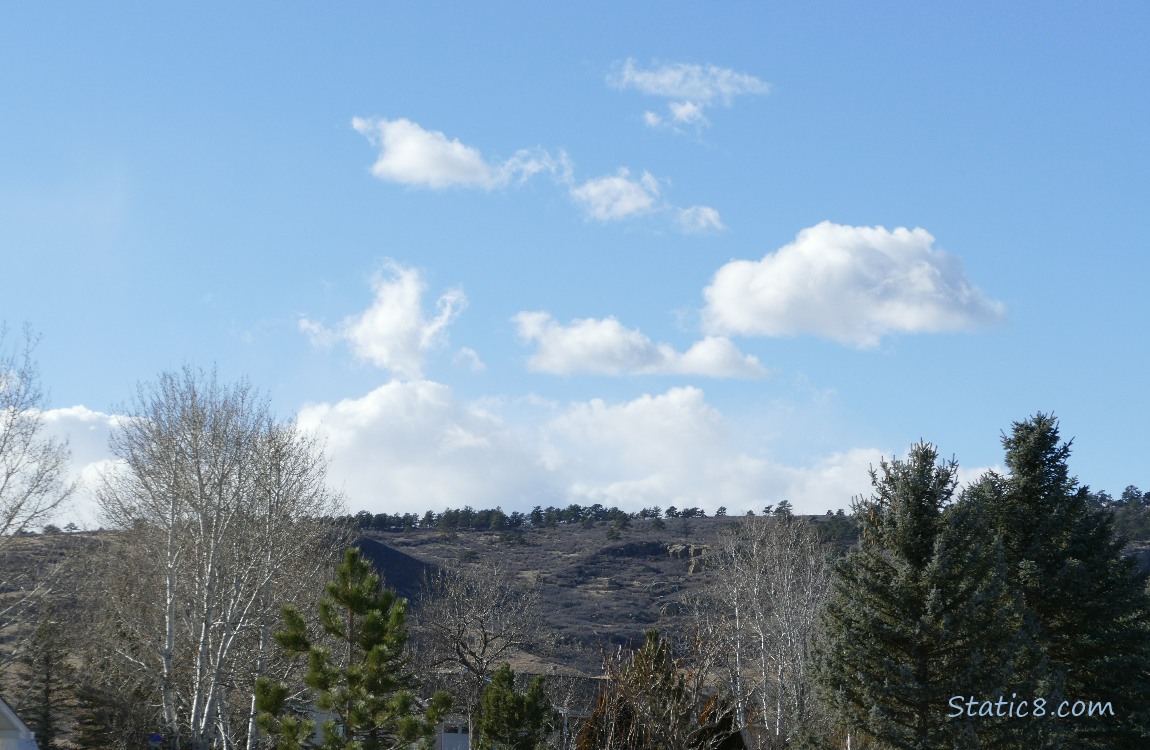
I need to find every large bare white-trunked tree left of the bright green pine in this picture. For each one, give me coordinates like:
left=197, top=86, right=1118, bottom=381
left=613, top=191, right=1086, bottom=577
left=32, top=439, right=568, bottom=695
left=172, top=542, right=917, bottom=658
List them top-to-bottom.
left=98, top=368, right=339, bottom=749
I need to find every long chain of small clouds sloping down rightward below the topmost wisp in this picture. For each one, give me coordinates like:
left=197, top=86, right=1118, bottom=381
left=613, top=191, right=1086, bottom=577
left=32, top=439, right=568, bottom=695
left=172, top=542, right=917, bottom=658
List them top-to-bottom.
left=352, top=117, right=725, bottom=234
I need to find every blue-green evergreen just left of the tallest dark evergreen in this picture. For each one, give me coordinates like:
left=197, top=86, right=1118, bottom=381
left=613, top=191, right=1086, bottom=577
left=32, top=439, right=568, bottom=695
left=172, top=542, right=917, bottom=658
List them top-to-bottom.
left=815, top=443, right=1019, bottom=750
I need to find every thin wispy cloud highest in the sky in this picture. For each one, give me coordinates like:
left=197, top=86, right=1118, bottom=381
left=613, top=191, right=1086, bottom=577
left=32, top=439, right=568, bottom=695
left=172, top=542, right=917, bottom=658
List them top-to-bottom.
left=607, top=58, right=771, bottom=128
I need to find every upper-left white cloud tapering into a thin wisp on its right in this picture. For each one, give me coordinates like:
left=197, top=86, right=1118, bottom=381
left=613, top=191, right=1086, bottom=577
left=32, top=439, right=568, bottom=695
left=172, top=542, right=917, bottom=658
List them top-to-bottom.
left=352, top=117, right=561, bottom=190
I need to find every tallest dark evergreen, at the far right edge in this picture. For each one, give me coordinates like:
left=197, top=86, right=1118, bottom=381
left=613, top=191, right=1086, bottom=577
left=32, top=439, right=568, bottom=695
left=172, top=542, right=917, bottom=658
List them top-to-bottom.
left=971, top=413, right=1150, bottom=749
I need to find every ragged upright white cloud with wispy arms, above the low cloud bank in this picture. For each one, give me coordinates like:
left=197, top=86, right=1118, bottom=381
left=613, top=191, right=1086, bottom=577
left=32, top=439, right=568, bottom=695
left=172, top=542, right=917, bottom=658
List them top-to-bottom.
left=299, top=262, right=467, bottom=378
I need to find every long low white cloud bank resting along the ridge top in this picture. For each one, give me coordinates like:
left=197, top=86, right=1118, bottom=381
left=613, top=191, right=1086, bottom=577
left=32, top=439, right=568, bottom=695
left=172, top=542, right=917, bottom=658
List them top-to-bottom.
left=299, top=381, right=880, bottom=513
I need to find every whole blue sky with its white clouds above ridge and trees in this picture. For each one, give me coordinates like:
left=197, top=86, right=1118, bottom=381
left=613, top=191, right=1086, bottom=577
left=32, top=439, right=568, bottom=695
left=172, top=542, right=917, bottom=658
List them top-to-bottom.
left=0, top=2, right=1150, bottom=526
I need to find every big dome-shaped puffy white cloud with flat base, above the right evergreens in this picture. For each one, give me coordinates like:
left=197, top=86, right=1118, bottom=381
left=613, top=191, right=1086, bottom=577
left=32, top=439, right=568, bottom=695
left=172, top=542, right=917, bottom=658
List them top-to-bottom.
left=703, top=216, right=1005, bottom=347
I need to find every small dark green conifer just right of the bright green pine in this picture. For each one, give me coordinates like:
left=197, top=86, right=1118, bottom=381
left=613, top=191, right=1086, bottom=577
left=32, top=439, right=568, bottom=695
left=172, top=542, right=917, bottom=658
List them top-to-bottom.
left=478, top=663, right=552, bottom=750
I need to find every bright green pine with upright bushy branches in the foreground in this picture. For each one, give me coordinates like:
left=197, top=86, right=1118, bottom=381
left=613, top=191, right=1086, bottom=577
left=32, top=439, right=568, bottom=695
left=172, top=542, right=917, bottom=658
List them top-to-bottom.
left=256, top=549, right=451, bottom=750
